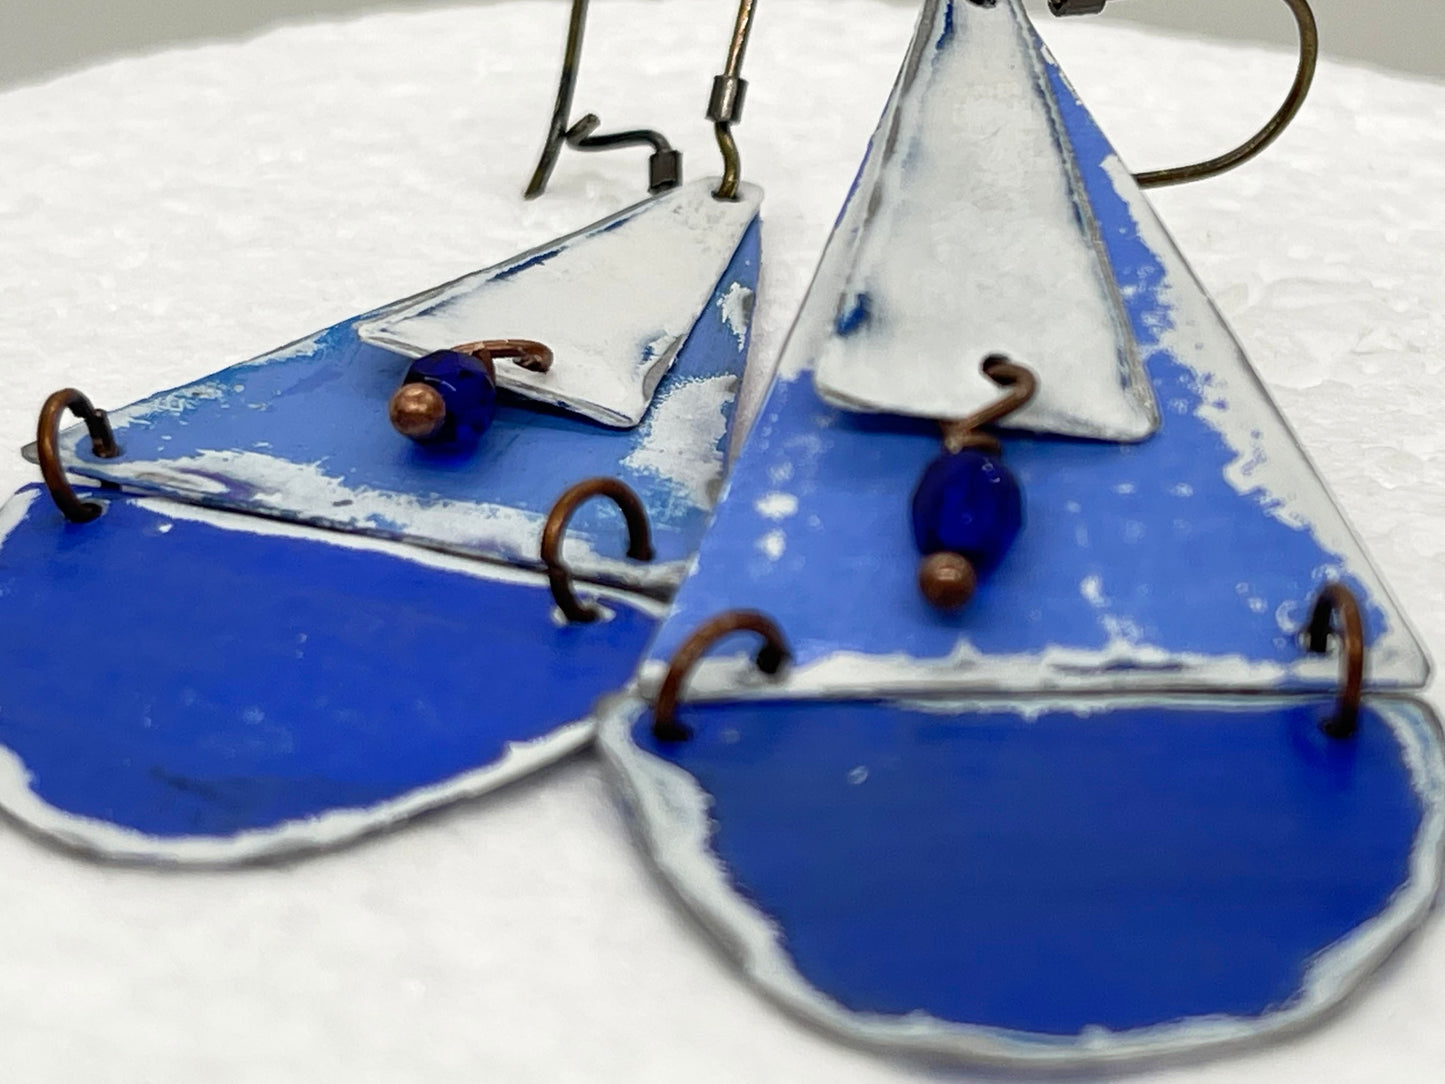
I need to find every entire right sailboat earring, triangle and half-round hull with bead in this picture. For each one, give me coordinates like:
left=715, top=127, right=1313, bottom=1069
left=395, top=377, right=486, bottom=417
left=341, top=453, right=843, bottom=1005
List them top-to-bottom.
left=600, top=0, right=1445, bottom=1068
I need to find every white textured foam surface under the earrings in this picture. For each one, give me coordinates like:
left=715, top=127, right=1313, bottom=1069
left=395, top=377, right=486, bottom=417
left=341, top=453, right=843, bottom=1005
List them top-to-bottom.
left=0, top=0, right=1445, bottom=1084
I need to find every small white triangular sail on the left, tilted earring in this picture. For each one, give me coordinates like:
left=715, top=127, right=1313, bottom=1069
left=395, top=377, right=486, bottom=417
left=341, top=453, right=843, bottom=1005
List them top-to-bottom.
left=357, top=181, right=763, bottom=428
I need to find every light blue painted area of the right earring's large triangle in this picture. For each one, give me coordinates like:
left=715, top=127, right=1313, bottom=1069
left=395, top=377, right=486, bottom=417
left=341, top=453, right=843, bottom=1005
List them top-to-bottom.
left=650, top=46, right=1425, bottom=685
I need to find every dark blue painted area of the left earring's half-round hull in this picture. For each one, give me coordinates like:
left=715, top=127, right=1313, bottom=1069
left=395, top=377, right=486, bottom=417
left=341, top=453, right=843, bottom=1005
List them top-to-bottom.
left=0, top=487, right=655, bottom=838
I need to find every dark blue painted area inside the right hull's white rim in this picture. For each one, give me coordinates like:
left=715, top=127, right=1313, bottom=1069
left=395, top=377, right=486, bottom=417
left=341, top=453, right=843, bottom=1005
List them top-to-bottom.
left=633, top=700, right=1423, bottom=1036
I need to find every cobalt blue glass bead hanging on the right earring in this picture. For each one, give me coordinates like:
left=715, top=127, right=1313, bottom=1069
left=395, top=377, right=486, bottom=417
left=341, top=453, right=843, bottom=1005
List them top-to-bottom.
left=913, top=448, right=1023, bottom=571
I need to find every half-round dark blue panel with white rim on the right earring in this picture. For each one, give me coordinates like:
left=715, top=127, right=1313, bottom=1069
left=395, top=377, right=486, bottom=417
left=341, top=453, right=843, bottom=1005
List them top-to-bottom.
left=600, top=695, right=1445, bottom=1070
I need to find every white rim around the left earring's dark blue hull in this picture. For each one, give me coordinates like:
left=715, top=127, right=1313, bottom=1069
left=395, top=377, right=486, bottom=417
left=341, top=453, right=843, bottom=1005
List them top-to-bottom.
left=0, top=491, right=666, bottom=866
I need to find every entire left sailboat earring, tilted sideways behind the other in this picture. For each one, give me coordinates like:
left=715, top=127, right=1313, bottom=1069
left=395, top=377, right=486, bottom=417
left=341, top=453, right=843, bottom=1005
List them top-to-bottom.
left=0, top=0, right=762, bottom=864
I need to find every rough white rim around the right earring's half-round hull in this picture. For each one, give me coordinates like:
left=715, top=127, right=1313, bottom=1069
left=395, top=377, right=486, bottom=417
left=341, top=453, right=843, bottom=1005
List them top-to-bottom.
left=597, top=695, right=1445, bottom=1068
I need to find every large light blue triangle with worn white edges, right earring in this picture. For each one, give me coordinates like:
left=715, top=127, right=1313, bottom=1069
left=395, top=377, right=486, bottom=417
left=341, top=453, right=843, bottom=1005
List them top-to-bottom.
left=630, top=4, right=1429, bottom=697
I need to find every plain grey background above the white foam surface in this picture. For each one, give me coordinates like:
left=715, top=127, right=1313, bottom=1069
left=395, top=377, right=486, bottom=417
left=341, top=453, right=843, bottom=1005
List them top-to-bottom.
left=0, top=0, right=1445, bottom=87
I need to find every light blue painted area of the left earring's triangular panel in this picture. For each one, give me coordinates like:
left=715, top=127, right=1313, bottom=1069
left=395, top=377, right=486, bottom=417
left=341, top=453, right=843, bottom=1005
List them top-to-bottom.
left=52, top=220, right=760, bottom=578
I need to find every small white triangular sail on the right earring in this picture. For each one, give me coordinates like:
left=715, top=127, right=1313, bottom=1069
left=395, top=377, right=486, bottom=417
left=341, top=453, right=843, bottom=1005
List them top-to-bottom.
left=816, top=0, right=1157, bottom=439
